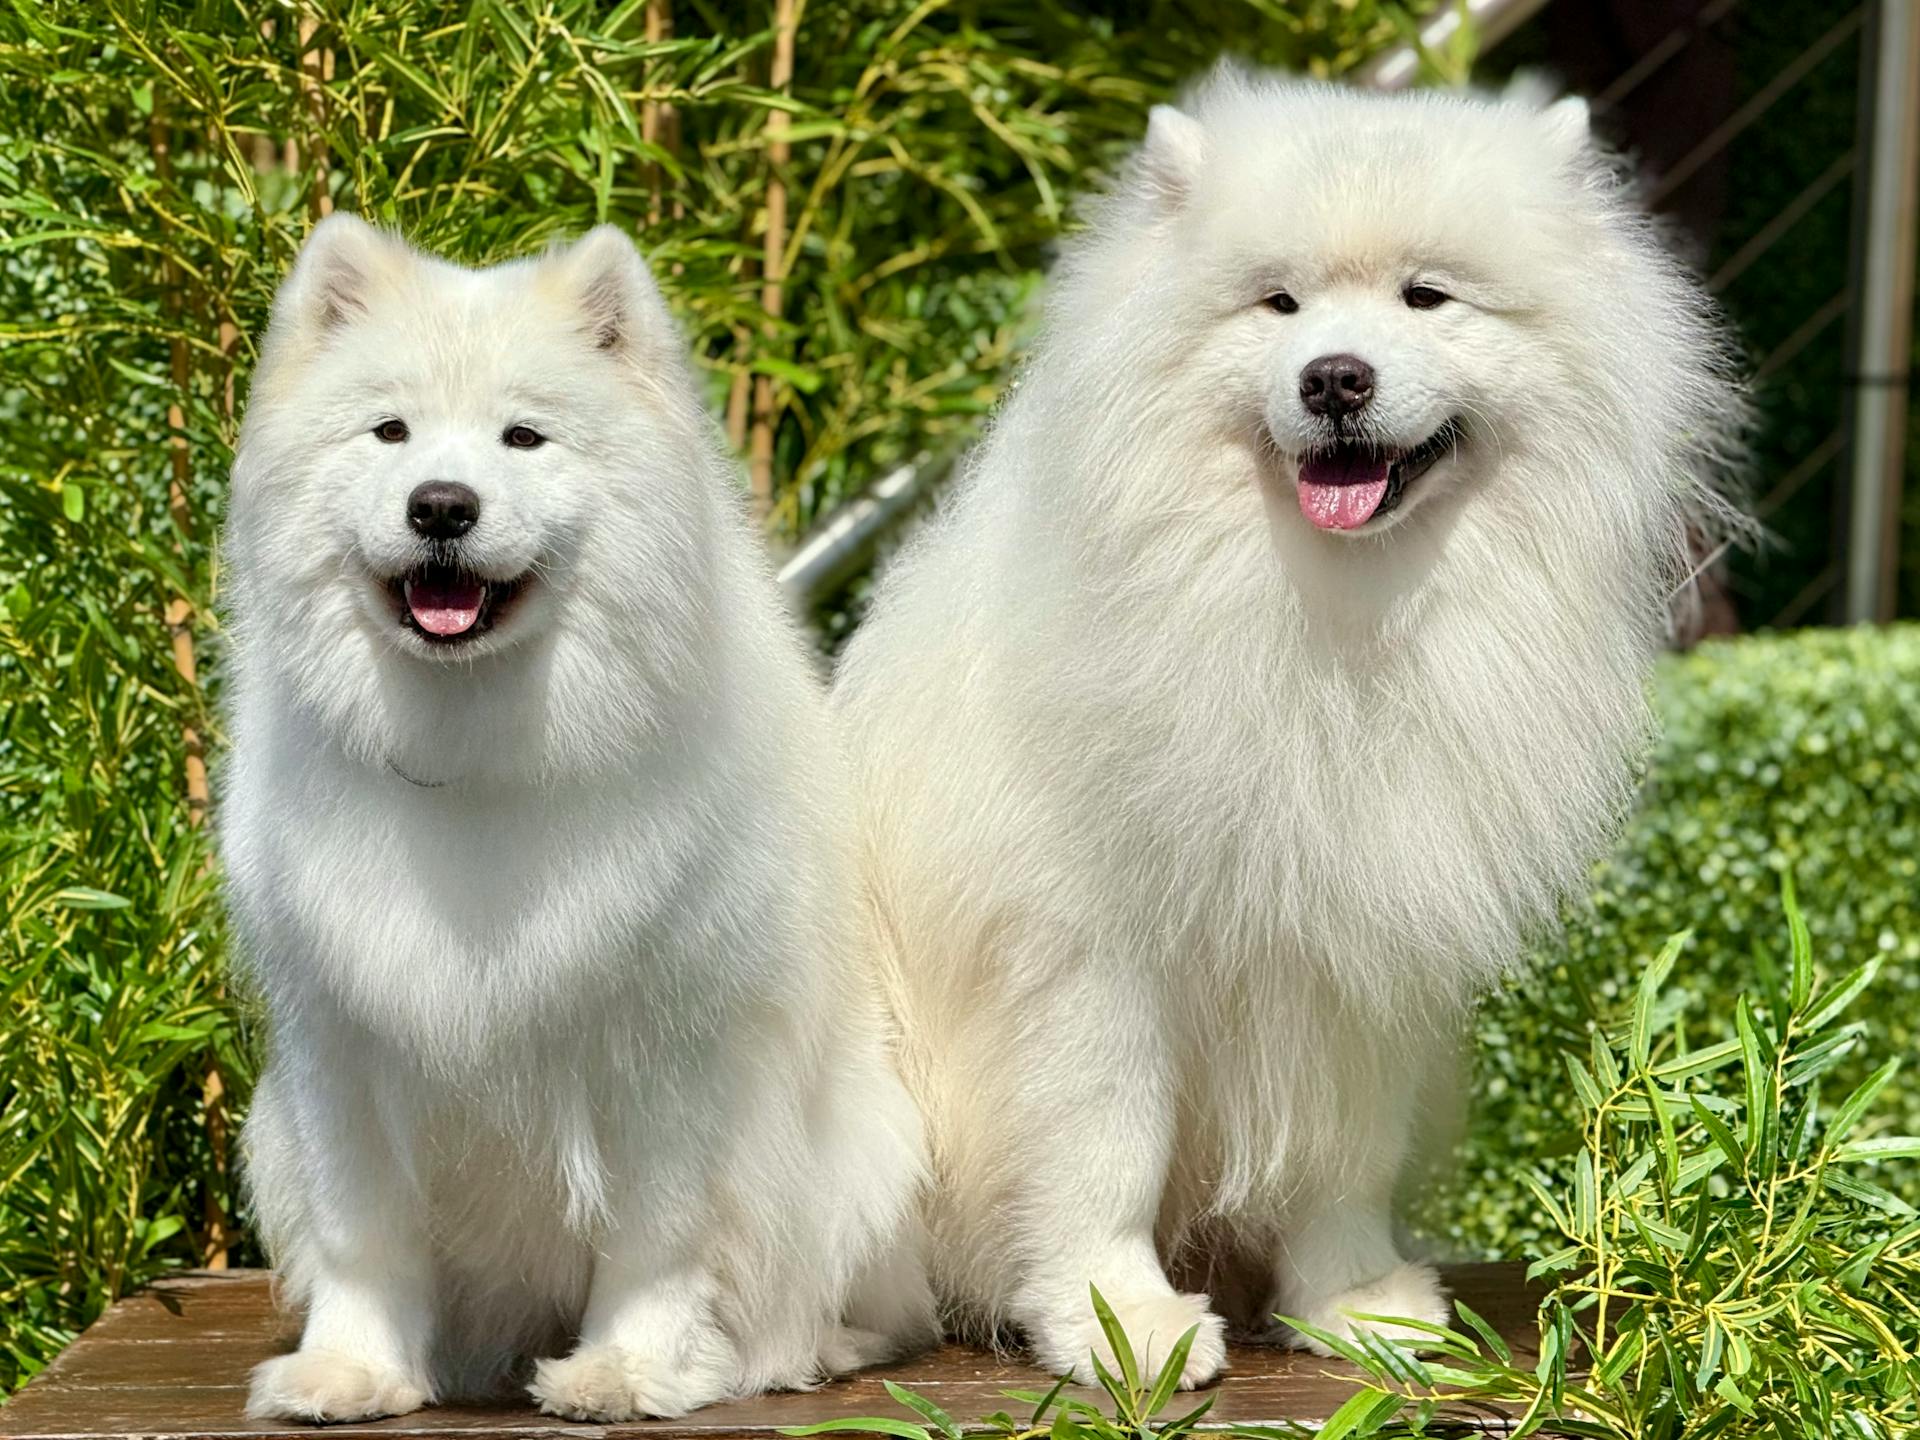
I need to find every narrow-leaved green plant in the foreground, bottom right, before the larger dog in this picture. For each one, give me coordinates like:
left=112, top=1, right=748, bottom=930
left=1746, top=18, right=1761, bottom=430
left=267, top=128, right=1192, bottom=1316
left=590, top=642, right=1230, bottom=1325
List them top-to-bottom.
left=814, top=887, right=1920, bottom=1440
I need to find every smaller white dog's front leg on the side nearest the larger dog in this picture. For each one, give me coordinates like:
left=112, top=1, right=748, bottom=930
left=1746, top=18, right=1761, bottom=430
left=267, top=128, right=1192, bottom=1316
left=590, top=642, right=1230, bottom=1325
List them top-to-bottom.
left=528, top=1116, right=741, bottom=1421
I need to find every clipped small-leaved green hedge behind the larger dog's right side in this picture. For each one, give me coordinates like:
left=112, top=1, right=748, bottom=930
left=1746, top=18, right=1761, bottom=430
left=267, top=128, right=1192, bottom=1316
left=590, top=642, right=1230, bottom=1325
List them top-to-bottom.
left=1425, top=626, right=1920, bottom=1254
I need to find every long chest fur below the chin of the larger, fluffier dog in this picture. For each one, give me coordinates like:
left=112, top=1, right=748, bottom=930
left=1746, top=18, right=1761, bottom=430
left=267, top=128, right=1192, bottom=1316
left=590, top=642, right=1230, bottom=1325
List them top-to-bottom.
left=1012, top=506, right=1649, bottom=1014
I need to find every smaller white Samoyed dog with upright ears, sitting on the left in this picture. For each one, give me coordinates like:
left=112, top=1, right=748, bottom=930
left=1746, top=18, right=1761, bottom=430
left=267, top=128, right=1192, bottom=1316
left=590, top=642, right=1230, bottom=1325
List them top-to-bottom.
left=221, top=217, right=933, bottom=1421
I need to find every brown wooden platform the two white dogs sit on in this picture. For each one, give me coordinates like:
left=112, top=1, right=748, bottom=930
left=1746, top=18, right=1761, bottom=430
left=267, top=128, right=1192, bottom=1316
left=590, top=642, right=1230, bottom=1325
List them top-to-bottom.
left=0, top=1265, right=1536, bottom=1440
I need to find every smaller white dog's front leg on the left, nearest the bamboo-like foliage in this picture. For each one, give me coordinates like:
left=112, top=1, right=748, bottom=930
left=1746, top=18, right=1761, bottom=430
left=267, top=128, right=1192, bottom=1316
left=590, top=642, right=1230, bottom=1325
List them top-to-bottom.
left=248, top=1027, right=434, bottom=1421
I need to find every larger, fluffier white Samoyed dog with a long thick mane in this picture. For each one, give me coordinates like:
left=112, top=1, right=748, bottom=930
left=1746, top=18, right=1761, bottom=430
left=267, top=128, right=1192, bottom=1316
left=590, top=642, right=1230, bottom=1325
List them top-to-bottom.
left=837, top=69, right=1741, bottom=1384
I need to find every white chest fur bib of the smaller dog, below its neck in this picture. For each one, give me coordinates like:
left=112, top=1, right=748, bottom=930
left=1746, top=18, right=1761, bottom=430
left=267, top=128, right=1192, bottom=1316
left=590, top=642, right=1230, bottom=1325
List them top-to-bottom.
left=219, top=725, right=741, bottom=1056
